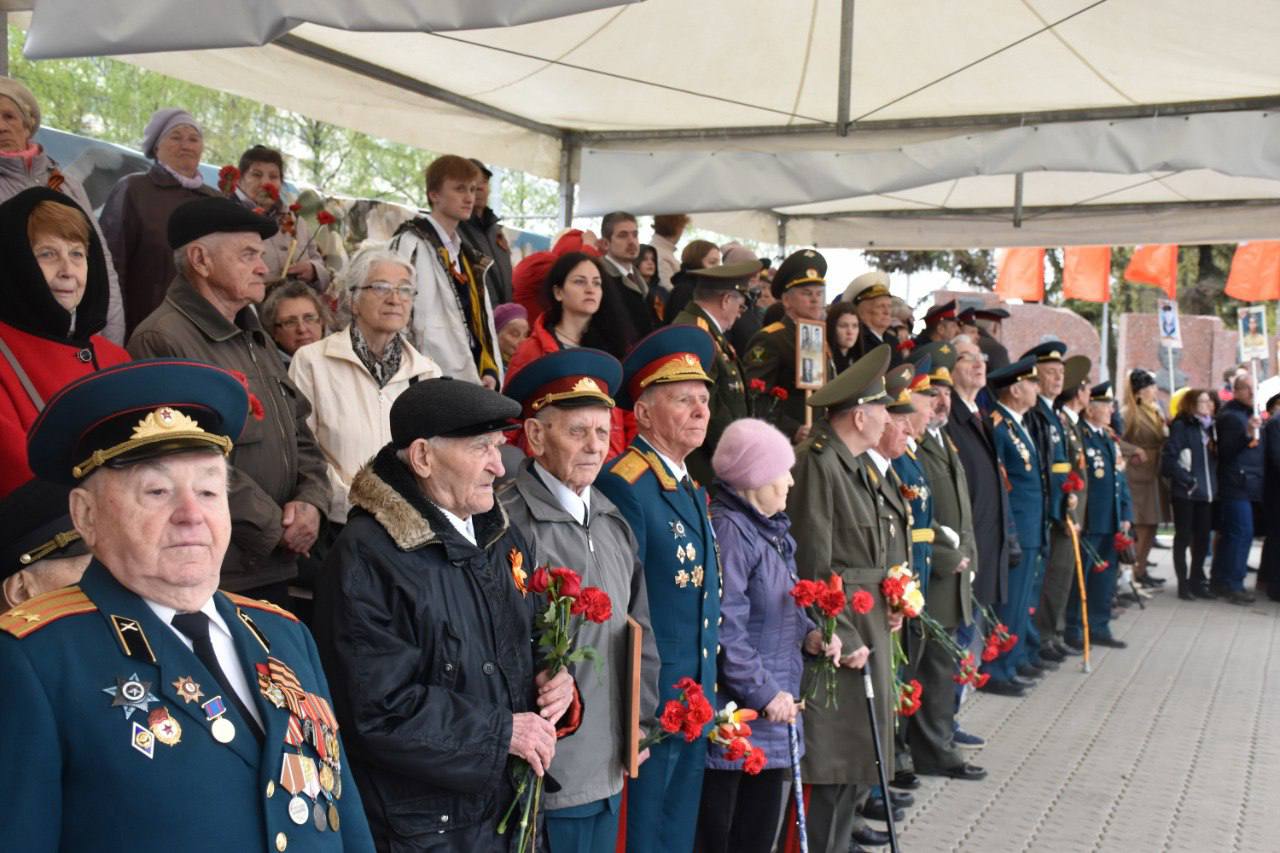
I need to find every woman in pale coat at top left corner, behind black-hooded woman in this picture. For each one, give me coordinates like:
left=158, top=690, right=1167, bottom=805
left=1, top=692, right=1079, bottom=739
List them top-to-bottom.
left=0, top=77, right=124, bottom=345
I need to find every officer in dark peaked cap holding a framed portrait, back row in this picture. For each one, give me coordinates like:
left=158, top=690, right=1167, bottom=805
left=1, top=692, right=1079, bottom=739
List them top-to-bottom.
left=742, top=248, right=835, bottom=443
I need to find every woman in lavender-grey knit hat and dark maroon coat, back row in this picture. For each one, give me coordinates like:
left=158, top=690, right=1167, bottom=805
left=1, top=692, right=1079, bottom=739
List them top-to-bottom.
left=102, top=109, right=218, bottom=337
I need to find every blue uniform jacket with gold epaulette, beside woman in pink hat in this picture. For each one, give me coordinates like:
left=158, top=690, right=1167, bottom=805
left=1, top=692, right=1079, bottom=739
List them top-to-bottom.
left=595, top=437, right=721, bottom=715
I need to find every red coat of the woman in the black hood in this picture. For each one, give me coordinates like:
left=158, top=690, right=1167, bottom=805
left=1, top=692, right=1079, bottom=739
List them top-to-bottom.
left=0, top=323, right=129, bottom=497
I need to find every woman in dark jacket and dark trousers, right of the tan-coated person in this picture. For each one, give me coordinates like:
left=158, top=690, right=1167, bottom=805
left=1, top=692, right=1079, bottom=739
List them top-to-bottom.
left=1160, top=388, right=1217, bottom=601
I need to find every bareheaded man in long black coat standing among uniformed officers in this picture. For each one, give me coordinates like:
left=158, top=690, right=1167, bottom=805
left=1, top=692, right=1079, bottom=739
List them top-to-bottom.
left=947, top=336, right=1010, bottom=676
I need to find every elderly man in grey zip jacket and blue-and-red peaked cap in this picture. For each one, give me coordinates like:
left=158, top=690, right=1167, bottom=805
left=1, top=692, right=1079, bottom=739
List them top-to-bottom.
left=502, top=350, right=658, bottom=853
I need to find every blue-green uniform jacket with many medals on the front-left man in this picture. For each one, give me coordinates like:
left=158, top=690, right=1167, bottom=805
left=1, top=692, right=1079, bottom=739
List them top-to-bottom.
left=0, top=562, right=374, bottom=853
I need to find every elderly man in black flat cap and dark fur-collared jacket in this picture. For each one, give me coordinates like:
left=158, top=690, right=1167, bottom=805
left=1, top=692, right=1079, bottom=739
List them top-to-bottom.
left=315, top=379, right=581, bottom=853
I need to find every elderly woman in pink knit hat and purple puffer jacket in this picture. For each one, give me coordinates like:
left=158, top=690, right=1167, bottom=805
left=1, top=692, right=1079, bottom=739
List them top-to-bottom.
left=696, top=419, right=840, bottom=853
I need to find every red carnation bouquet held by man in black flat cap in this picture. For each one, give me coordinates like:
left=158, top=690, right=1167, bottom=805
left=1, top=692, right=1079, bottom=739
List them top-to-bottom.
left=498, top=566, right=613, bottom=853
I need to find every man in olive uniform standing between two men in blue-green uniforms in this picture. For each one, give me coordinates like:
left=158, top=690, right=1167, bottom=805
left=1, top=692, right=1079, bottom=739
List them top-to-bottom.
left=1036, top=355, right=1092, bottom=660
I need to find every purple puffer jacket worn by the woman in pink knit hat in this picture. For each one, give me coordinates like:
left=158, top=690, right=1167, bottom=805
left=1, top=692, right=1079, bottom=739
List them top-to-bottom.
left=707, top=483, right=815, bottom=770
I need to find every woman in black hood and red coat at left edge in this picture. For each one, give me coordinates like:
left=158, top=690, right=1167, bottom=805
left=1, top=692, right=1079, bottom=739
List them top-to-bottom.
left=0, top=187, right=129, bottom=497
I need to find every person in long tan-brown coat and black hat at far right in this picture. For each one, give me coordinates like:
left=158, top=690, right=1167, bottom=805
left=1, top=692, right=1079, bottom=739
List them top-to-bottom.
left=1123, top=368, right=1169, bottom=587
